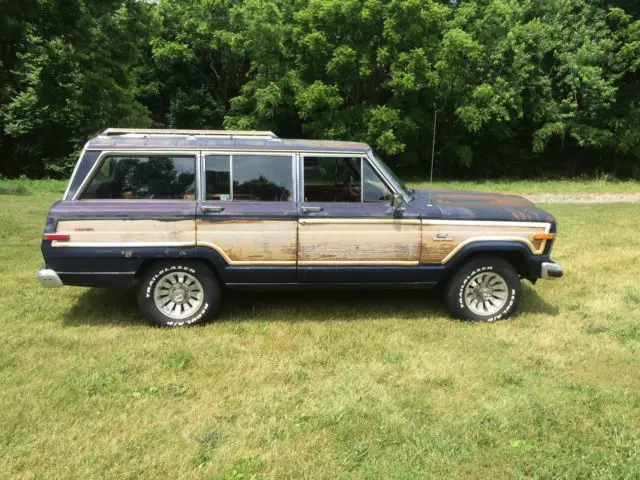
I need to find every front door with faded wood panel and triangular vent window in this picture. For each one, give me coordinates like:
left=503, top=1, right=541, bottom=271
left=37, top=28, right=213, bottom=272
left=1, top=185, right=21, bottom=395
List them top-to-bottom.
left=298, top=154, right=421, bottom=283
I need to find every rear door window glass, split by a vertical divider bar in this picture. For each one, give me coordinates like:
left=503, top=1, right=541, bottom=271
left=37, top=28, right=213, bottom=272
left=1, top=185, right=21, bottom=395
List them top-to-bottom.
left=205, top=155, right=293, bottom=202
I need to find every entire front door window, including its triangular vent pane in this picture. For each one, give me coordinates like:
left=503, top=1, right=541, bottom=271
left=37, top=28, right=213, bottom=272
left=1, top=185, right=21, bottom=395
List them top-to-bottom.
left=304, top=157, right=392, bottom=203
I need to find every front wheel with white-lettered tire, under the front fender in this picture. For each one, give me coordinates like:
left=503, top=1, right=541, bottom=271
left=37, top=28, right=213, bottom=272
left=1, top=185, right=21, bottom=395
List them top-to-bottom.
left=445, top=257, right=522, bottom=322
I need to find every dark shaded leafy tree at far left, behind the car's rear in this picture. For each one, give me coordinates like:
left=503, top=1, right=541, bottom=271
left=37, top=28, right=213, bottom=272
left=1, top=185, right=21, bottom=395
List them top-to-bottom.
left=0, top=0, right=151, bottom=176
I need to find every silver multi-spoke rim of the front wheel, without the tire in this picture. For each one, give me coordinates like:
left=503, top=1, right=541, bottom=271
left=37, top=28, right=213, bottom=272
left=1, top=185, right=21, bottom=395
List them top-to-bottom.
left=464, top=272, right=509, bottom=316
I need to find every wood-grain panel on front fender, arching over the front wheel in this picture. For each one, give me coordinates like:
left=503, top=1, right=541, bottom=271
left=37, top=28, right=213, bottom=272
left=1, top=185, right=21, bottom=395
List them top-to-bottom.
left=420, top=222, right=549, bottom=263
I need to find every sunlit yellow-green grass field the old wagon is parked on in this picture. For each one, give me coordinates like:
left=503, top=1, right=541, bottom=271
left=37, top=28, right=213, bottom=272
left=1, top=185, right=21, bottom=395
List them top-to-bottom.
left=0, top=182, right=640, bottom=479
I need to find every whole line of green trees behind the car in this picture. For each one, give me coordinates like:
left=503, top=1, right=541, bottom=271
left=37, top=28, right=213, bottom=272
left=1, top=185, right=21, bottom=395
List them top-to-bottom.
left=0, top=0, right=640, bottom=178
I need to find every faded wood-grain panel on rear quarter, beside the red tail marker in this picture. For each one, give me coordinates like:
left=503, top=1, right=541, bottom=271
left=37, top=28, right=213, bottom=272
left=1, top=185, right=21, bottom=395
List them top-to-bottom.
left=52, top=220, right=196, bottom=247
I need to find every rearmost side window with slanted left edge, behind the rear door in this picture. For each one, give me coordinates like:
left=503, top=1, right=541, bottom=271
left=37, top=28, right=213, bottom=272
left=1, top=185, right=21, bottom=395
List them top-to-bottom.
left=80, top=155, right=196, bottom=200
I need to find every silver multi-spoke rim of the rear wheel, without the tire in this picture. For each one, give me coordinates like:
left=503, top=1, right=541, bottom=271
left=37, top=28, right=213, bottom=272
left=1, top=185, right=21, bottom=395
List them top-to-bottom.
left=153, top=272, right=204, bottom=320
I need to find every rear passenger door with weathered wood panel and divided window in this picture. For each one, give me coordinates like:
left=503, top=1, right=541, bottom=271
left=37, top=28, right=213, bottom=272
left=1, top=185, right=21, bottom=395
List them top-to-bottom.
left=196, top=152, right=297, bottom=284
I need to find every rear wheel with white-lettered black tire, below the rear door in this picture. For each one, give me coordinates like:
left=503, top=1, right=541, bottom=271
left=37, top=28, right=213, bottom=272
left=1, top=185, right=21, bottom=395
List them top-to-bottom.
left=138, top=260, right=222, bottom=327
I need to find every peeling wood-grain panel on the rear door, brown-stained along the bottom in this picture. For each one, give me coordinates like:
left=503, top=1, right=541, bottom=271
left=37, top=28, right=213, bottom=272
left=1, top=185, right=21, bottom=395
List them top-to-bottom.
left=197, top=220, right=298, bottom=265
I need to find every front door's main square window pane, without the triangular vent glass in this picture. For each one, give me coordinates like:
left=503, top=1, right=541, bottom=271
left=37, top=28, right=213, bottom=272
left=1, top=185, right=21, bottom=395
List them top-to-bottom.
left=304, top=157, right=361, bottom=202
